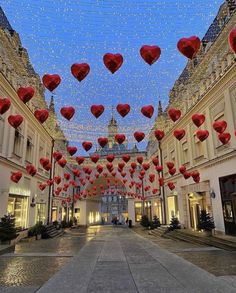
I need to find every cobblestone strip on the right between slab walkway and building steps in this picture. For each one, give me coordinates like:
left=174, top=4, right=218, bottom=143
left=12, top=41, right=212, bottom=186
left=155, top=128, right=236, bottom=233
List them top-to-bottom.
left=135, top=228, right=236, bottom=276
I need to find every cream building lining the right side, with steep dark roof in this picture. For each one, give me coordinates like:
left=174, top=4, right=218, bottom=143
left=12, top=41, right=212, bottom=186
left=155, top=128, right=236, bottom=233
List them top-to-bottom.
left=148, top=1, right=236, bottom=235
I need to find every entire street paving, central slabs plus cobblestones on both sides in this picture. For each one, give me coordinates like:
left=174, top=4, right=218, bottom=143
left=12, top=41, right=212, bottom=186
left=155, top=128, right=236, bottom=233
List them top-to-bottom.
left=0, top=227, right=236, bottom=293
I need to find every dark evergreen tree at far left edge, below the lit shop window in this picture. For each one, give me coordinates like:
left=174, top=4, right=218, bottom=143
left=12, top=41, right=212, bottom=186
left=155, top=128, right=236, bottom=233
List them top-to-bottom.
left=0, top=215, right=18, bottom=244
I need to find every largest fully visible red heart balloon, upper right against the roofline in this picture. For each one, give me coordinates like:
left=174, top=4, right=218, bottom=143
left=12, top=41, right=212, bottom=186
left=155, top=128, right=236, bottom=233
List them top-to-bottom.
left=177, top=36, right=201, bottom=59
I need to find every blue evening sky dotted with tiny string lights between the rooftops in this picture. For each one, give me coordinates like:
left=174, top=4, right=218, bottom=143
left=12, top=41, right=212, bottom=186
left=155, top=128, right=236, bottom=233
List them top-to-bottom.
left=0, top=0, right=223, bottom=153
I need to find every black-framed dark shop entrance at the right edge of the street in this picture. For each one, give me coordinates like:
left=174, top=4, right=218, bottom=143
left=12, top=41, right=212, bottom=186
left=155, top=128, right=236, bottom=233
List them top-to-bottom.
left=219, top=174, right=236, bottom=235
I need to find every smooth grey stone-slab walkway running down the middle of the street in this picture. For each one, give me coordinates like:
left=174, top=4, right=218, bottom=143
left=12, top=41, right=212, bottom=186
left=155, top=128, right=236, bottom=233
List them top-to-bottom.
left=37, top=227, right=236, bottom=293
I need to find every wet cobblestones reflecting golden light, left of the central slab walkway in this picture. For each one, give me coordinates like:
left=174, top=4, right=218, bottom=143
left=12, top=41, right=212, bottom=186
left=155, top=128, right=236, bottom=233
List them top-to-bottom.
left=0, top=227, right=98, bottom=292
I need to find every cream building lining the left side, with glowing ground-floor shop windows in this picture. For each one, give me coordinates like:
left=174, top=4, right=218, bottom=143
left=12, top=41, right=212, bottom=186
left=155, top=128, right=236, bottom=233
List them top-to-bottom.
left=0, top=9, right=74, bottom=229
